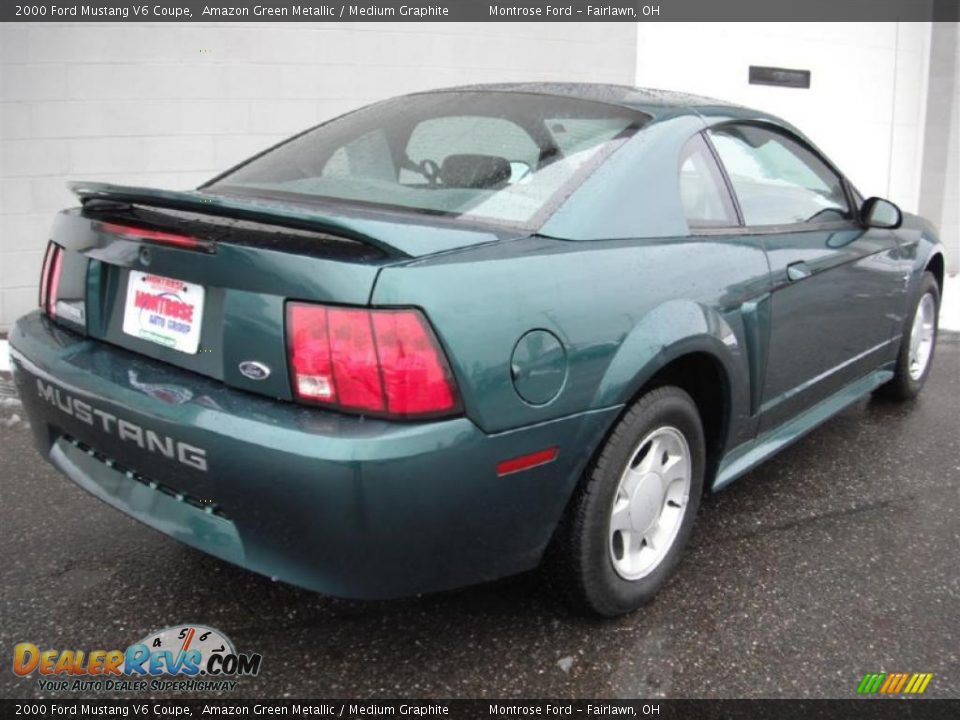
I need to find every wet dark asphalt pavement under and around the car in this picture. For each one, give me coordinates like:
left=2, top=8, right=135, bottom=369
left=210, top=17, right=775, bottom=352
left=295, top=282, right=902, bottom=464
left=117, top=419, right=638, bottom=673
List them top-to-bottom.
left=0, top=334, right=960, bottom=698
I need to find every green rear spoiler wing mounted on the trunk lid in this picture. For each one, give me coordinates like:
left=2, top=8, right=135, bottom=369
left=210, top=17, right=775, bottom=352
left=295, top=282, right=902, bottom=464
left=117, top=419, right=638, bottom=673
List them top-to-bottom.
left=67, top=181, right=408, bottom=257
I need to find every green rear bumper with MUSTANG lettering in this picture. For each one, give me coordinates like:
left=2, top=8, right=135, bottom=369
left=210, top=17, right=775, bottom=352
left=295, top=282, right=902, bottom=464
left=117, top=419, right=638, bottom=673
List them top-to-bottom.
left=10, top=313, right=618, bottom=598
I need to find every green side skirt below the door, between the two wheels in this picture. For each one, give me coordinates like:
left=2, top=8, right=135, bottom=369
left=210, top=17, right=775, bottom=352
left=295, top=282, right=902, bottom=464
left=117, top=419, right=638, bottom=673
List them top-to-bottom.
left=711, top=370, right=893, bottom=492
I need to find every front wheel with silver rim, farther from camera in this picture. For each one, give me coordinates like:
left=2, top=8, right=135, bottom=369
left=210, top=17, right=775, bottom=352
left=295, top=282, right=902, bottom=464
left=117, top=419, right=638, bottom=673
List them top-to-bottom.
left=879, top=272, right=940, bottom=401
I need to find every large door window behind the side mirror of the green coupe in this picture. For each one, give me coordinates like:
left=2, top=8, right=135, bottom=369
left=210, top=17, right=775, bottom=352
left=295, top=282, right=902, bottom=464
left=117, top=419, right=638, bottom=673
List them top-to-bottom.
left=709, top=125, right=850, bottom=225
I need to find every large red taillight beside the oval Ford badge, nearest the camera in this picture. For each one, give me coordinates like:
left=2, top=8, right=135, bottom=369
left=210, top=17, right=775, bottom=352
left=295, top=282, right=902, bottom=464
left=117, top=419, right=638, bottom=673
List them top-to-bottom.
left=287, top=302, right=460, bottom=418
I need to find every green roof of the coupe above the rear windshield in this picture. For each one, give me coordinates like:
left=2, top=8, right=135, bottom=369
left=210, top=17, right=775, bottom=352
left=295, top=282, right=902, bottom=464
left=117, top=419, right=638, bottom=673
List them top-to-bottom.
left=428, top=82, right=757, bottom=119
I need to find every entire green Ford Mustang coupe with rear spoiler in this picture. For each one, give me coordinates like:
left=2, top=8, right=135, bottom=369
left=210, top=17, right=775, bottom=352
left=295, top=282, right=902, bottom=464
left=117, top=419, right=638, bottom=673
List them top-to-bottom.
left=10, top=84, right=944, bottom=615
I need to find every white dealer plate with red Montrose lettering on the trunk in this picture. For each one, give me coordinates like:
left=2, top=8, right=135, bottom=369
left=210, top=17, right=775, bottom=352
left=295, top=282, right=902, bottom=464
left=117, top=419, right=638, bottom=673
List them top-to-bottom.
left=123, top=270, right=204, bottom=354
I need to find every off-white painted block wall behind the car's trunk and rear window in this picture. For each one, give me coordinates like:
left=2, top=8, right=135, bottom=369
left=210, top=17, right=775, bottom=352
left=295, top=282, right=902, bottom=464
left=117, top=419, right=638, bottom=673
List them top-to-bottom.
left=0, top=23, right=636, bottom=330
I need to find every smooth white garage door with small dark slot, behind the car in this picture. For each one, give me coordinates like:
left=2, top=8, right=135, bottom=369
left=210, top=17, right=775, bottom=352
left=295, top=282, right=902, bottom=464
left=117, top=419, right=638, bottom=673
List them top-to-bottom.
left=637, top=23, right=930, bottom=212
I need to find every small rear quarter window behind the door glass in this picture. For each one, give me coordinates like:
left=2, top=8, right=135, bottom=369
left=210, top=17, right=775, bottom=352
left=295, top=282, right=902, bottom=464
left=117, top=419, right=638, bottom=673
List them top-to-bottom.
left=680, top=135, right=737, bottom=229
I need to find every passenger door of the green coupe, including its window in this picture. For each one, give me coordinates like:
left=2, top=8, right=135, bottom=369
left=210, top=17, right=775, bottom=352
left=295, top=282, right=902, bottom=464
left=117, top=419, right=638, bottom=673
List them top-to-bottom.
left=708, top=123, right=903, bottom=432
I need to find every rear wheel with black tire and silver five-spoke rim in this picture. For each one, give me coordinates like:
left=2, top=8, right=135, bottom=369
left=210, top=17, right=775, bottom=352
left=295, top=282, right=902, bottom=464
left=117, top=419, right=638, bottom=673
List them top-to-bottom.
left=547, top=386, right=706, bottom=617
